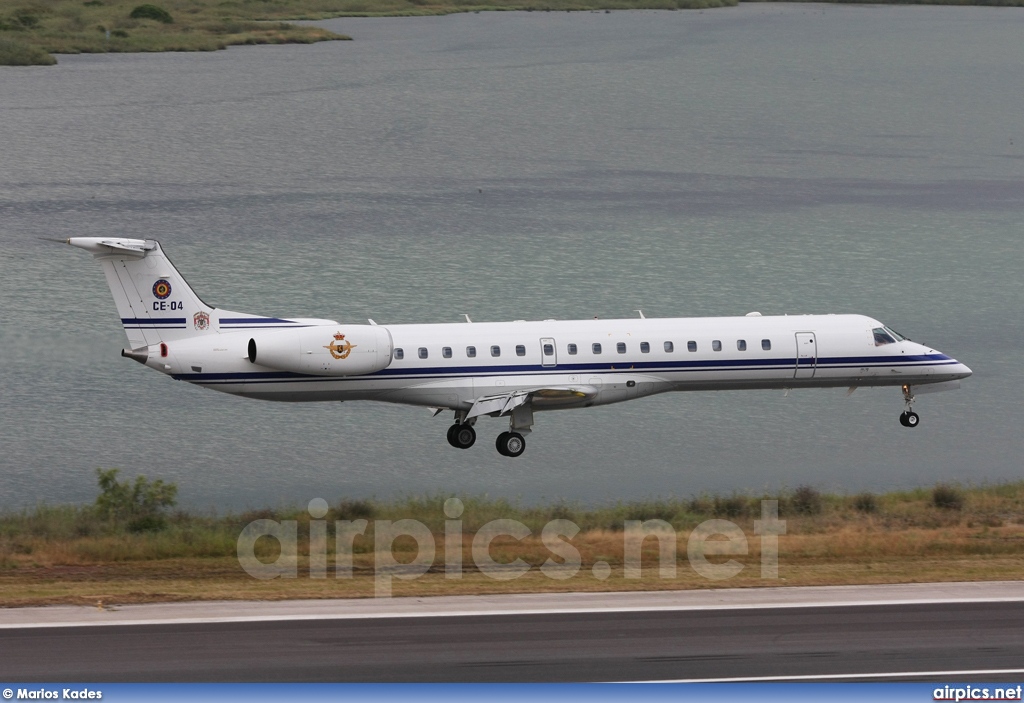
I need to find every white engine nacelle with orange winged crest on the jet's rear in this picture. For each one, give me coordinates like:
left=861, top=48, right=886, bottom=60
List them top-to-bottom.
left=248, top=324, right=391, bottom=376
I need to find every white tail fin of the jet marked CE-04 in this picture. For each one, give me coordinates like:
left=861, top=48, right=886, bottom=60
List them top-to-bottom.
left=67, top=236, right=213, bottom=349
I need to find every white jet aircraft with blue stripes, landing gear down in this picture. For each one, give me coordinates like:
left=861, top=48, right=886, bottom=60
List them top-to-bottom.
left=67, top=236, right=971, bottom=456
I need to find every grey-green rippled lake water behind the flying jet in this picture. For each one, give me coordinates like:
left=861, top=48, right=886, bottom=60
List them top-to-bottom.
left=0, top=4, right=1024, bottom=511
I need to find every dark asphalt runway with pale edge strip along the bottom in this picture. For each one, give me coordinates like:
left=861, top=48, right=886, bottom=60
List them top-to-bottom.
left=0, top=582, right=1024, bottom=683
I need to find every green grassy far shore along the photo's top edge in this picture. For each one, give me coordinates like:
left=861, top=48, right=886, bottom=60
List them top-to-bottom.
left=0, top=0, right=1024, bottom=65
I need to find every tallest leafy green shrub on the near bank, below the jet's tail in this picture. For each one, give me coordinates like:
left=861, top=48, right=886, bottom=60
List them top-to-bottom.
left=96, top=469, right=178, bottom=532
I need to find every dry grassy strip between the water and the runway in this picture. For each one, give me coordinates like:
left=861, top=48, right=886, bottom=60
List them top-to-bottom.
left=0, top=482, right=1024, bottom=607
